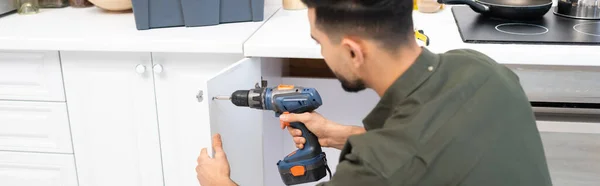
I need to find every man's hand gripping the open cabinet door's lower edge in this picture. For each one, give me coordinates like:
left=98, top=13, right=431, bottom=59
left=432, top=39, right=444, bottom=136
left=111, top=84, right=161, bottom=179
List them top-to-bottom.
left=196, top=134, right=236, bottom=186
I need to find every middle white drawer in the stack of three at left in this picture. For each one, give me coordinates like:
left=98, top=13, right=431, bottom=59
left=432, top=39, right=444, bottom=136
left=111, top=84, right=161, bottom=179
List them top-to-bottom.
left=0, top=101, right=73, bottom=153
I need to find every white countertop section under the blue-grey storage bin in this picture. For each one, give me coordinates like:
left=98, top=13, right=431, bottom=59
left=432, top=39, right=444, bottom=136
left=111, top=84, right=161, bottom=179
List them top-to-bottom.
left=0, top=6, right=279, bottom=54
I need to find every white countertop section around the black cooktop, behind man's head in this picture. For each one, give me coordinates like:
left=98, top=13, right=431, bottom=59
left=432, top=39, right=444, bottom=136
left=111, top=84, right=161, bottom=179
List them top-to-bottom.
left=244, top=6, right=600, bottom=66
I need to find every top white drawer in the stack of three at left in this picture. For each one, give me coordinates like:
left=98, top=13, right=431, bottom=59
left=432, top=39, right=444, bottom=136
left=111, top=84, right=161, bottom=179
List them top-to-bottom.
left=0, top=51, right=65, bottom=101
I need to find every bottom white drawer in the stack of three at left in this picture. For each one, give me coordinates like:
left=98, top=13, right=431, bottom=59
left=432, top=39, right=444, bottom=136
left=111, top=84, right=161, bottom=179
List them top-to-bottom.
left=0, top=151, right=77, bottom=186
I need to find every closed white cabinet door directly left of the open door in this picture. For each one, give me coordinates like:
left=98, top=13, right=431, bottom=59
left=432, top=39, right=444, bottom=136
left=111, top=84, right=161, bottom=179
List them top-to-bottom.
left=152, top=53, right=243, bottom=186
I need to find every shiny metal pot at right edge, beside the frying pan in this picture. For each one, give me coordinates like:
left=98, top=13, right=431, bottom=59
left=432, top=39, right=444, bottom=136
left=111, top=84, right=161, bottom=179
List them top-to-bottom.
left=554, top=0, right=600, bottom=20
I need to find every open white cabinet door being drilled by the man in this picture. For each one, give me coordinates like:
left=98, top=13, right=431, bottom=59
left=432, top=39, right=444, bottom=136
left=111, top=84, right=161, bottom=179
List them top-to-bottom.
left=204, top=58, right=264, bottom=185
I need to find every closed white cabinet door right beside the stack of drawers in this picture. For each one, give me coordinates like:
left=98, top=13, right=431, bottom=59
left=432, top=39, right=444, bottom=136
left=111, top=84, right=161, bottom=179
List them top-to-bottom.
left=61, top=52, right=163, bottom=186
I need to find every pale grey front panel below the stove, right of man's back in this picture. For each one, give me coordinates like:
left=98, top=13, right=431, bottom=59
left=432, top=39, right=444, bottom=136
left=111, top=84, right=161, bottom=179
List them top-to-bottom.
left=538, top=121, right=600, bottom=186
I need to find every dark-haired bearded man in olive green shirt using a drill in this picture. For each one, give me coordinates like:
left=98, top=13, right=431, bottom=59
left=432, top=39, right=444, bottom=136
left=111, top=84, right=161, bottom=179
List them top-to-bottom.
left=197, top=0, right=552, bottom=186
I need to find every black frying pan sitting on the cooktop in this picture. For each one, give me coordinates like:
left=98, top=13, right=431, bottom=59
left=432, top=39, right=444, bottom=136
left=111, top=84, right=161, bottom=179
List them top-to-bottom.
left=438, top=0, right=552, bottom=20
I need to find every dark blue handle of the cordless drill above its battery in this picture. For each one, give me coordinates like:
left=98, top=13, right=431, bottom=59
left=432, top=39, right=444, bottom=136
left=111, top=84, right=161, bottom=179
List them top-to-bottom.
left=284, top=122, right=322, bottom=161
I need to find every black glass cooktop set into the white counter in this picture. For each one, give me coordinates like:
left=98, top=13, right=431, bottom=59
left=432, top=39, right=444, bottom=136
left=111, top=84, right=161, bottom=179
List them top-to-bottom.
left=452, top=5, right=600, bottom=45
